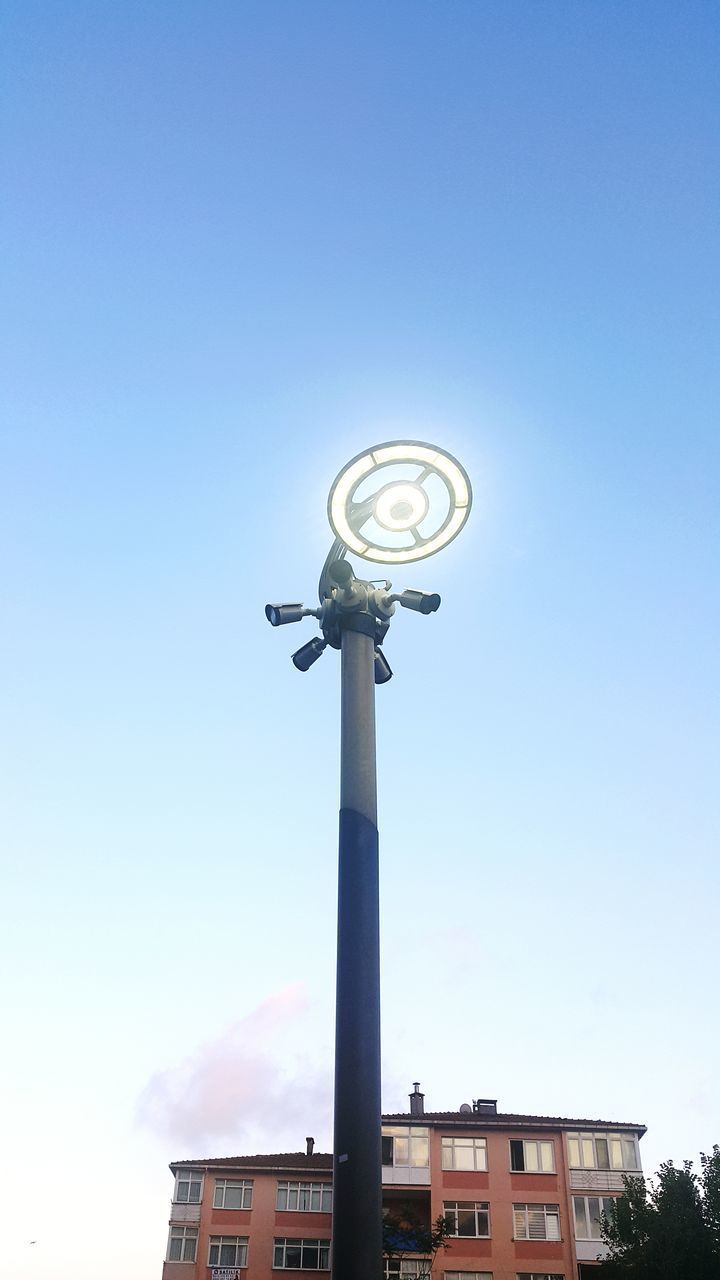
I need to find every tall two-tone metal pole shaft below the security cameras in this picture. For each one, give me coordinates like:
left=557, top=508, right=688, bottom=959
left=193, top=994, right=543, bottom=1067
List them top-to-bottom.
left=332, top=623, right=382, bottom=1280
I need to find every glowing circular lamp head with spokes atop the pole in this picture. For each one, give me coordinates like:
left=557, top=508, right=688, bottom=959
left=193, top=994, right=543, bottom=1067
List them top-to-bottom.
left=328, top=440, right=473, bottom=564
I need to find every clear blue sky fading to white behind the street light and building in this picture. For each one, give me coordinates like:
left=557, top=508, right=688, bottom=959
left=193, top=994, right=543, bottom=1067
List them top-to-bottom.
left=0, top=0, right=720, bottom=1280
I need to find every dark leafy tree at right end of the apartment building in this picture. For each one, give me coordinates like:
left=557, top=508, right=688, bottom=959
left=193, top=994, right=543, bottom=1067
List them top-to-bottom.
left=597, top=1147, right=720, bottom=1280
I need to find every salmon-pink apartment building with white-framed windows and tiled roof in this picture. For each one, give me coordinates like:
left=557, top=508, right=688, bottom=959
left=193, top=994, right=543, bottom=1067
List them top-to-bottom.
left=163, top=1084, right=646, bottom=1280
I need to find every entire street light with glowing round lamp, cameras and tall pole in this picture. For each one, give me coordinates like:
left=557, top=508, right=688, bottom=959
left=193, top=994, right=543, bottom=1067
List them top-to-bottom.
left=265, top=442, right=471, bottom=1280
